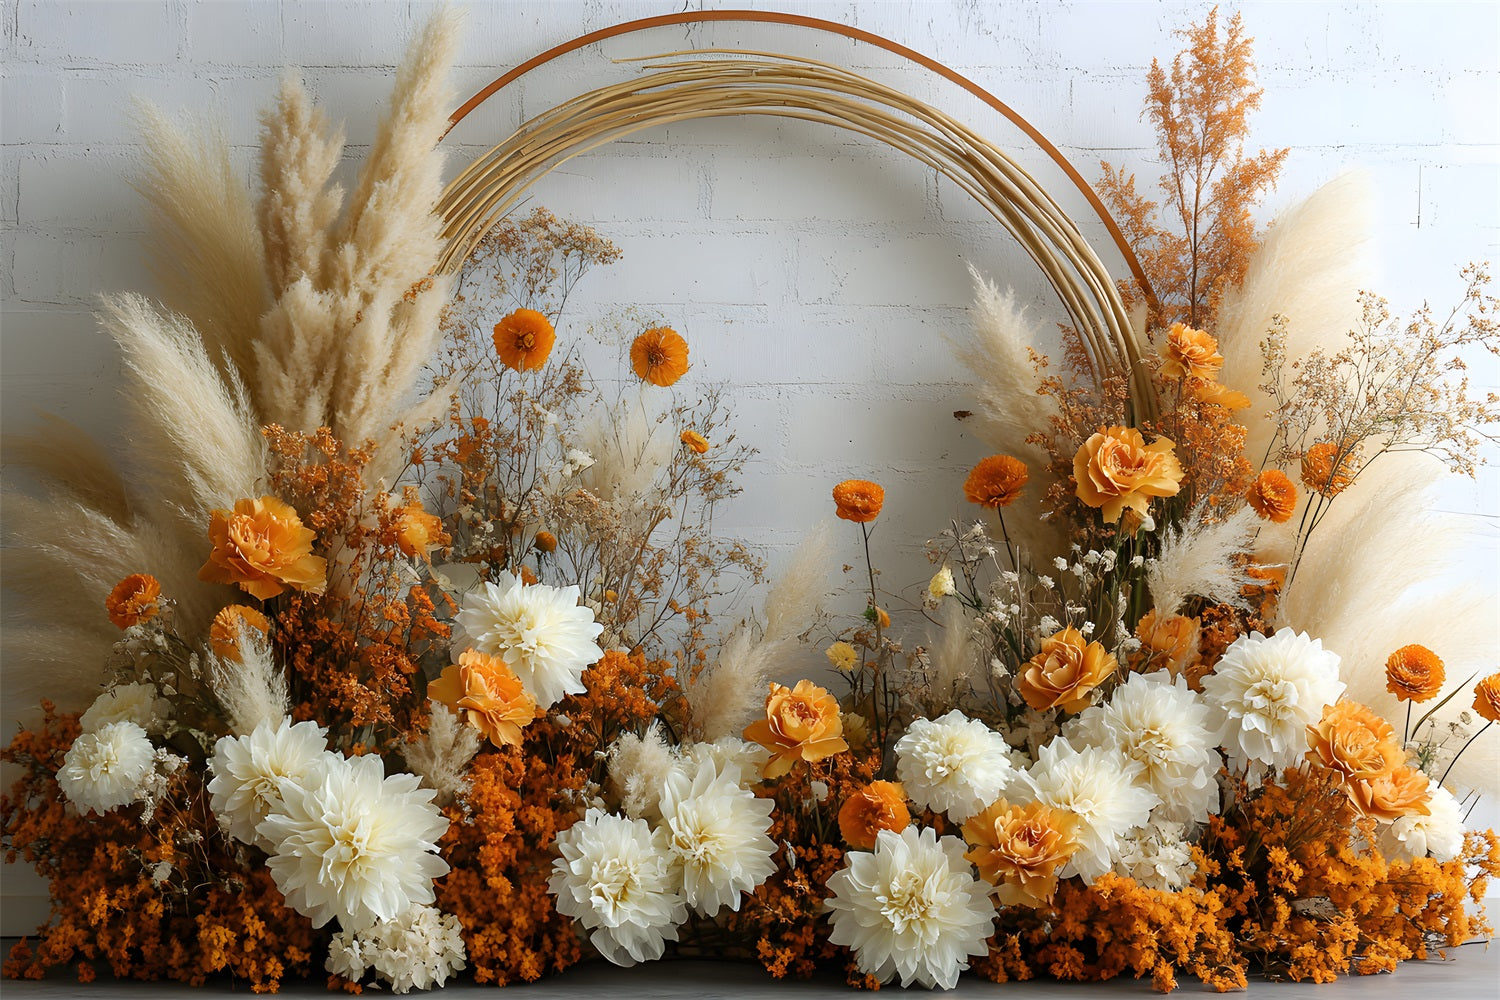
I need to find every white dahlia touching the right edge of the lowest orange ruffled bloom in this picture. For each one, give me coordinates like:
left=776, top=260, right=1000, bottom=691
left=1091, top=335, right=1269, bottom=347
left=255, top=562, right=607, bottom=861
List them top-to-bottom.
left=1029, top=736, right=1161, bottom=882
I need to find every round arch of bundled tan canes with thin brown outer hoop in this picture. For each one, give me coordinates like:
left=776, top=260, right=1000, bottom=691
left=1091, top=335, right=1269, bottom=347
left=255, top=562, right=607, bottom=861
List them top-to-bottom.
left=438, top=10, right=1158, bottom=420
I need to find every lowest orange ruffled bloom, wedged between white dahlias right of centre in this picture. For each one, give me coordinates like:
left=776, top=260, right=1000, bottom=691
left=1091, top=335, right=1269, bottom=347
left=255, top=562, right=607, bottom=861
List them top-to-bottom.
left=963, top=799, right=1079, bottom=907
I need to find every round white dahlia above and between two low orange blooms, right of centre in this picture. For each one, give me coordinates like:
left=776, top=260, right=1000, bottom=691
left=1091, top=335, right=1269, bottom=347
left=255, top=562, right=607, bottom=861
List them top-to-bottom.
left=896, top=709, right=1016, bottom=823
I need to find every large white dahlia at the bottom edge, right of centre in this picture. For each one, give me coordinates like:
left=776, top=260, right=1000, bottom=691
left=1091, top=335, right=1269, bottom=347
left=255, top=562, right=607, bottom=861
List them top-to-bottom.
left=827, top=826, right=995, bottom=990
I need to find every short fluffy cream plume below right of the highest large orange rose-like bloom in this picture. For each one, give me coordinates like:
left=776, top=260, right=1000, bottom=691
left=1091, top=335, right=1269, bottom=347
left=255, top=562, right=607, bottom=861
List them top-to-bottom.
left=1146, top=504, right=1259, bottom=615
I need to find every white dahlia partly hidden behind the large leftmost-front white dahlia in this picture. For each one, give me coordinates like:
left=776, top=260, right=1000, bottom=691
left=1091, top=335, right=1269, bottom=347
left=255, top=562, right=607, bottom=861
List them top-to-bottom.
left=209, top=717, right=330, bottom=852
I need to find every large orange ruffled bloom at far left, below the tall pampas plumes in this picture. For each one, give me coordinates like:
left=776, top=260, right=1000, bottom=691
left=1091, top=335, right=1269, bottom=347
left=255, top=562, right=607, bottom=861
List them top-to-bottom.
left=198, top=496, right=329, bottom=601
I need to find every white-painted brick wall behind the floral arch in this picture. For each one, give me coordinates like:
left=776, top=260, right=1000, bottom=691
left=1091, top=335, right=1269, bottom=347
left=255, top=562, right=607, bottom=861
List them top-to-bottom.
left=0, top=0, right=1500, bottom=933
